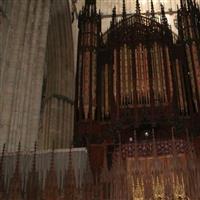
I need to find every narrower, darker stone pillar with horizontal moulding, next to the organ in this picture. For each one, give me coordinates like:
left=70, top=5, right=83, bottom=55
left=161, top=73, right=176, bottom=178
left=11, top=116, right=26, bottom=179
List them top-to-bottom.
left=39, top=0, right=75, bottom=149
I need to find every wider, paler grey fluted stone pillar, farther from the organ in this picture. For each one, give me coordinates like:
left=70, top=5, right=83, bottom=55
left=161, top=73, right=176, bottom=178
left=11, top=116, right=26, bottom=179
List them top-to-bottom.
left=0, top=0, right=51, bottom=151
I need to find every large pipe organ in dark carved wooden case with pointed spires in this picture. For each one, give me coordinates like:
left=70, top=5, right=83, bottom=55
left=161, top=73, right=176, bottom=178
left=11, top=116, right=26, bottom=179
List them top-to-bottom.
left=74, top=1, right=200, bottom=151
